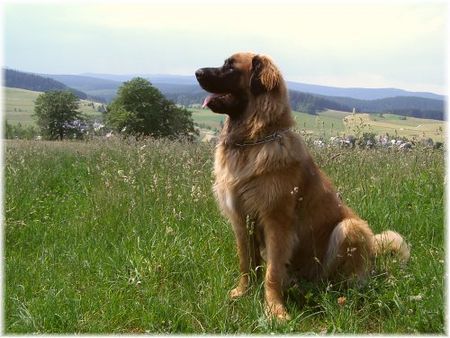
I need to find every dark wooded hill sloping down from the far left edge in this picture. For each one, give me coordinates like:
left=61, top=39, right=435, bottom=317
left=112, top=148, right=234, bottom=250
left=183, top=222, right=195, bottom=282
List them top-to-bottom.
left=3, top=69, right=88, bottom=100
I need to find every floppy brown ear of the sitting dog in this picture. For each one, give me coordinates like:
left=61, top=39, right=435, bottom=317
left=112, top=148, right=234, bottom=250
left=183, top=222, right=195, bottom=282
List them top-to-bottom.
left=250, top=55, right=281, bottom=95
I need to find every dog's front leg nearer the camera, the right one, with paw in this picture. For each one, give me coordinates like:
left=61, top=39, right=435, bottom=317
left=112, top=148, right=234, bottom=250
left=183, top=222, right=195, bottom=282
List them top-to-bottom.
left=264, top=210, right=295, bottom=320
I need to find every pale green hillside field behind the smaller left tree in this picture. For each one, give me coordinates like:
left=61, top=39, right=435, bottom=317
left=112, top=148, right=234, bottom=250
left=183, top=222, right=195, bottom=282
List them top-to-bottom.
left=3, top=87, right=101, bottom=126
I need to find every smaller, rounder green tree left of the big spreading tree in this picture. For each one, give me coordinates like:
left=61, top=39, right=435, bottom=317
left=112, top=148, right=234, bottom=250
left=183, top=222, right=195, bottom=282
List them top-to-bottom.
left=34, top=91, right=84, bottom=140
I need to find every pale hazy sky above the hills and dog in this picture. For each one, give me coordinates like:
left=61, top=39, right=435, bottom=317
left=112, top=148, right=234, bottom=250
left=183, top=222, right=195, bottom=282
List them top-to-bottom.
left=1, top=0, right=448, bottom=94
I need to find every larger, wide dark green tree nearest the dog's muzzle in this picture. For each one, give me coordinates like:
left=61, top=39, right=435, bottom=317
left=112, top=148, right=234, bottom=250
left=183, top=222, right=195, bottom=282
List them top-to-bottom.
left=106, top=77, right=196, bottom=138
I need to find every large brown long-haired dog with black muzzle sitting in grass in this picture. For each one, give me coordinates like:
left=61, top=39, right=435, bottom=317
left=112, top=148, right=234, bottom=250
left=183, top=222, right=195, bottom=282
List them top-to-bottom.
left=195, top=53, right=409, bottom=319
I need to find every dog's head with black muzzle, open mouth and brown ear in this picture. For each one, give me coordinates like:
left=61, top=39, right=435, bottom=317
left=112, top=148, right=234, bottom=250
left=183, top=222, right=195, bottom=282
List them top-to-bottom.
left=195, top=53, right=283, bottom=117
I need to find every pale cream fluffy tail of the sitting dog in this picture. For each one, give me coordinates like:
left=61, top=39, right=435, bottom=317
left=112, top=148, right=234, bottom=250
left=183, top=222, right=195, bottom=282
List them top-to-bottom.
left=373, top=230, right=411, bottom=263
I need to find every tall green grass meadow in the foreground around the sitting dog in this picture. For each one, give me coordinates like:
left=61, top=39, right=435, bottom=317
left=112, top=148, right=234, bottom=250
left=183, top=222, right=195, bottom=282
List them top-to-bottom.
left=4, top=139, right=445, bottom=334
